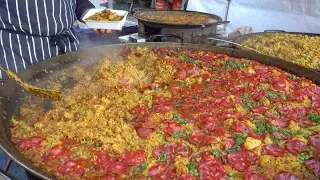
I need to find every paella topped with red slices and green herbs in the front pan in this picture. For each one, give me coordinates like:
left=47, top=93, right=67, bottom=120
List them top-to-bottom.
left=11, top=47, right=320, bottom=180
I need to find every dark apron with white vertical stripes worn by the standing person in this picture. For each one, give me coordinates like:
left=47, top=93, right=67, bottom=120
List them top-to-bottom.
left=0, top=0, right=79, bottom=79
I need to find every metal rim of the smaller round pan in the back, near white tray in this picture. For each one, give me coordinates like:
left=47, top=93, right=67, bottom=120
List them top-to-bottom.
left=134, top=9, right=229, bottom=29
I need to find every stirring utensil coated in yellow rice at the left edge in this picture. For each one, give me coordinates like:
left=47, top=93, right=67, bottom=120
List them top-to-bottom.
left=0, top=67, right=62, bottom=100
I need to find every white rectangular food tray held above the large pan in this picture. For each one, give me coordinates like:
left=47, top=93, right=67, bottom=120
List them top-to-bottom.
left=83, top=9, right=128, bottom=30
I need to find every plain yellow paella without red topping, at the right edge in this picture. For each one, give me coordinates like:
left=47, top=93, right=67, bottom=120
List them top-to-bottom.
left=242, top=33, right=320, bottom=69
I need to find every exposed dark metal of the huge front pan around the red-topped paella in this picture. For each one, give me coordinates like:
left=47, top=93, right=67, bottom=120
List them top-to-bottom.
left=0, top=43, right=320, bottom=179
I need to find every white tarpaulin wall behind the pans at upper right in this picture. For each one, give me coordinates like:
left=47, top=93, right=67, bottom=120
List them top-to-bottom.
left=187, top=0, right=320, bottom=33
